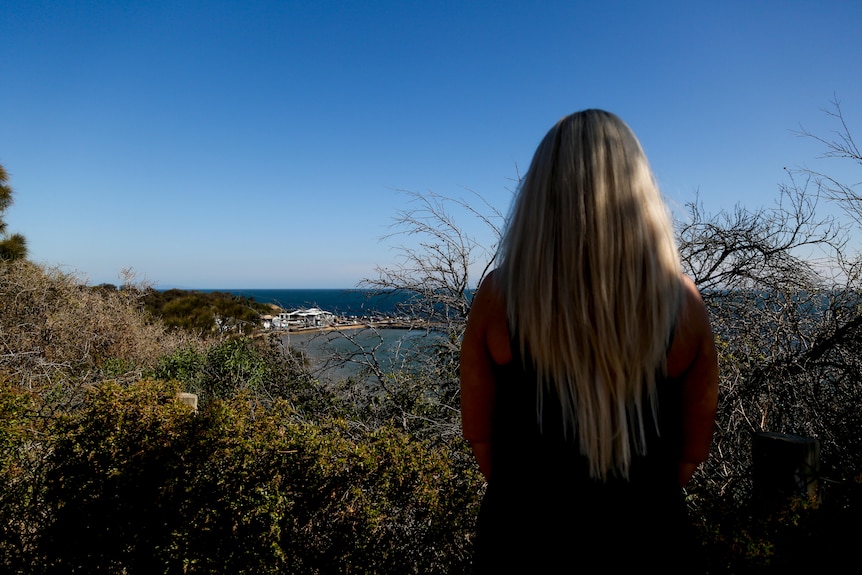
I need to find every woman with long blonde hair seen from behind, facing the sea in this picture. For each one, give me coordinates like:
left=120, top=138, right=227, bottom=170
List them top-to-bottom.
left=461, top=110, right=718, bottom=573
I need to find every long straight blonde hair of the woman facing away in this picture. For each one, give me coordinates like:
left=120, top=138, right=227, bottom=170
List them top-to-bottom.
left=497, top=110, right=681, bottom=479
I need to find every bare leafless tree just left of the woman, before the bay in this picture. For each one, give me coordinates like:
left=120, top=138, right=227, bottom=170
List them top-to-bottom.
left=296, top=192, right=510, bottom=441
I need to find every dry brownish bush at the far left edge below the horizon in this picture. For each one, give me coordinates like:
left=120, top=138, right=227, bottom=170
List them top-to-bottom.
left=0, top=260, right=191, bottom=395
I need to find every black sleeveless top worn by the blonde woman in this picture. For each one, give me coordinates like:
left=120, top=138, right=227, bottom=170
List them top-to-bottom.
left=474, top=344, right=697, bottom=573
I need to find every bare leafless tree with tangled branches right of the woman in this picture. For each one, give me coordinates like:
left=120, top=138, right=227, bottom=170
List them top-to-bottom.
left=678, top=101, right=862, bottom=502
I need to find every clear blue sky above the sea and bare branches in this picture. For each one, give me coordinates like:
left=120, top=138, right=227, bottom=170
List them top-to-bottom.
left=0, top=0, right=862, bottom=288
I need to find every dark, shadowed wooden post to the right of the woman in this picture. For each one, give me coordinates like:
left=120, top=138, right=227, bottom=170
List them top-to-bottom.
left=751, top=432, right=820, bottom=507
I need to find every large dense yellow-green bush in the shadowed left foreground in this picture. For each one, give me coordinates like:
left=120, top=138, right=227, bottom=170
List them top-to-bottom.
left=7, top=381, right=480, bottom=574
